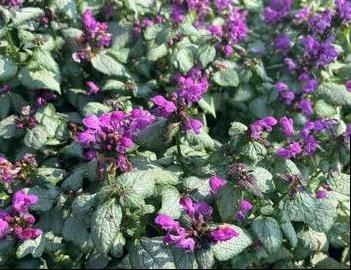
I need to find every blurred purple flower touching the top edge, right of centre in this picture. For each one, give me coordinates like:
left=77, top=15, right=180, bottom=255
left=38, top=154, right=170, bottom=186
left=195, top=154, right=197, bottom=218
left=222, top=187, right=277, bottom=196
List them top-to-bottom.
left=264, top=0, right=293, bottom=24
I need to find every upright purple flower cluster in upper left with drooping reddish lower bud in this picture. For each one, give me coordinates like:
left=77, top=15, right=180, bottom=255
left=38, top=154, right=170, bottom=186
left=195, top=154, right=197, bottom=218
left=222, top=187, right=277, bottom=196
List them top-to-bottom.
left=72, top=9, right=112, bottom=62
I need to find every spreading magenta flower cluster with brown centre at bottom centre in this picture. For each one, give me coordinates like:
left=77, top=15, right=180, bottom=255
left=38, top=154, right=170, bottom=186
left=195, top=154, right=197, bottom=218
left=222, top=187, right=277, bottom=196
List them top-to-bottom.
left=155, top=197, right=239, bottom=251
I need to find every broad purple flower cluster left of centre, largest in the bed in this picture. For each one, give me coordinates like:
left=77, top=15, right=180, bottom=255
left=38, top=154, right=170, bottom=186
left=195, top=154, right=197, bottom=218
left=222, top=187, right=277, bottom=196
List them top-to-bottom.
left=77, top=109, right=154, bottom=171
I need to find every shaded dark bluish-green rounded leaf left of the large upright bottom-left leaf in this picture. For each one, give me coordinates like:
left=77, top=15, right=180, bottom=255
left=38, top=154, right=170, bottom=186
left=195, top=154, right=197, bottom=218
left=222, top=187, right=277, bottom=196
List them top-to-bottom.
left=62, top=215, right=89, bottom=247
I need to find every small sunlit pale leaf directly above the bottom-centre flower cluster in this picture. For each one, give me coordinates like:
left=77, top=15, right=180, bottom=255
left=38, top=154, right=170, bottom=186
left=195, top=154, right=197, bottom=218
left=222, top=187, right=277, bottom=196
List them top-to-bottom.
left=158, top=186, right=182, bottom=219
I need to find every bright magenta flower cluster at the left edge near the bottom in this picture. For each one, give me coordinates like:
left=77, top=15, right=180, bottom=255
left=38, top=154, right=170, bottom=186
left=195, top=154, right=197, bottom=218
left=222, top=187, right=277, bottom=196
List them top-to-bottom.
left=0, top=189, right=42, bottom=241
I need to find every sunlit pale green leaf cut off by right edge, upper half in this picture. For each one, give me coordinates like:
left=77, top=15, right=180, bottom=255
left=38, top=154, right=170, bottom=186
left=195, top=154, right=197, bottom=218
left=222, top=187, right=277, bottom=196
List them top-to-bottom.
left=315, top=83, right=351, bottom=107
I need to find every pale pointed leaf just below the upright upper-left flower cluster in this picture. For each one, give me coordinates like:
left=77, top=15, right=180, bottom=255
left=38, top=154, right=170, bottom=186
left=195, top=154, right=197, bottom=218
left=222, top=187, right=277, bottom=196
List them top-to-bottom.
left=91, top=51, right=129, bottom=77
